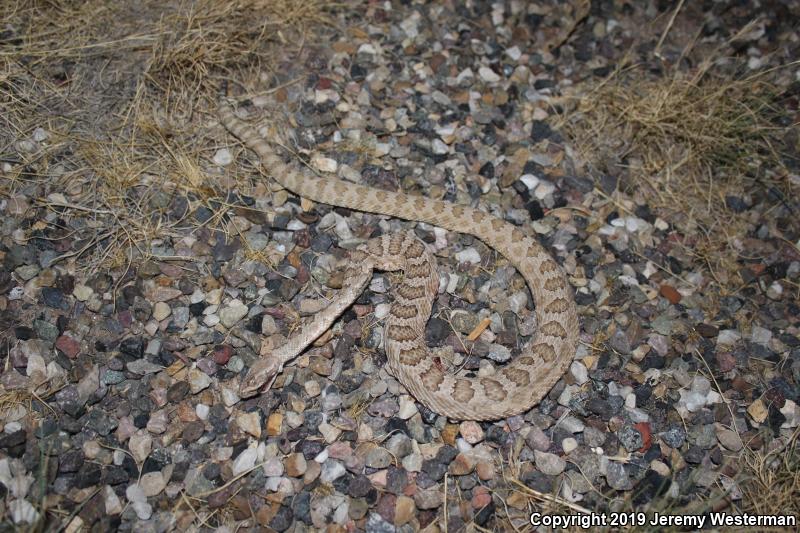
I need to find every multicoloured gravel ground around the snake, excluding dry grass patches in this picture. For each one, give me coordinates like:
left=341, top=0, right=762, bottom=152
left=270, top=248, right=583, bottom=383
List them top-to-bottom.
left=0, top=1, right=800, bottom=533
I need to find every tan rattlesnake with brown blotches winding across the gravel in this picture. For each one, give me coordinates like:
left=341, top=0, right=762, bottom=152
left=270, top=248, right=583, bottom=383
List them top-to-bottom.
left=219, top=95, right=579, bottom=420
